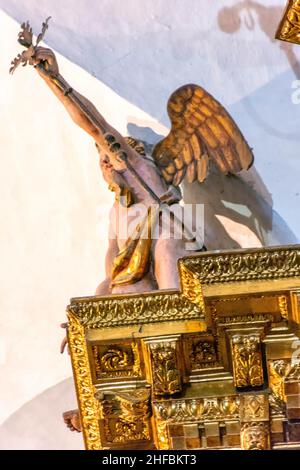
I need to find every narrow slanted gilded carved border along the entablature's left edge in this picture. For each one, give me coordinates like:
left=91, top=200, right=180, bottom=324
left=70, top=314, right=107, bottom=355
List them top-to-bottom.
left=68, top=312, right=101, bottom=450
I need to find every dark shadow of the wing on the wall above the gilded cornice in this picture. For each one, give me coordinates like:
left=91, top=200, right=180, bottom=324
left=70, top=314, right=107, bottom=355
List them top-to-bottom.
left=127, top=123, right=298, bottom=250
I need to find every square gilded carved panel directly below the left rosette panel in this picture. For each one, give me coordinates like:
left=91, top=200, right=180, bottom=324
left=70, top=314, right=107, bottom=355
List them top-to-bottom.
left=96, top=389, right=151, bottom=444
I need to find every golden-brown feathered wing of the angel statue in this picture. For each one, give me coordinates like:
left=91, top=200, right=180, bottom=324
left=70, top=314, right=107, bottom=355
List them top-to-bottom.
left=153, top=85, right=254, bottom=186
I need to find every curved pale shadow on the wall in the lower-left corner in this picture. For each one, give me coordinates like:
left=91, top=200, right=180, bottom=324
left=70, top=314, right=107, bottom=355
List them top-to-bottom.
left=0, top=378, right=84, bottom=450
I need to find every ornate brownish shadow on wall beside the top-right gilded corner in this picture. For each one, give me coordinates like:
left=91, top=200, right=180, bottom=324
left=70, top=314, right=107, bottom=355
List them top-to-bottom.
left=218, top=0, right=300, bottom=79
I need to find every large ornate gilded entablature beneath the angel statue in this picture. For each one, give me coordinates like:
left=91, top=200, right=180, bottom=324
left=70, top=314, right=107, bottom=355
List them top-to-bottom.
left=63, top=247, right=300, bottom=450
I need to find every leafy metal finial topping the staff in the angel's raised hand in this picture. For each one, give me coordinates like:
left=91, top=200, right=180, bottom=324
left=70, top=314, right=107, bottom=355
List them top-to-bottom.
left=9, top=16, right=51, bottom=73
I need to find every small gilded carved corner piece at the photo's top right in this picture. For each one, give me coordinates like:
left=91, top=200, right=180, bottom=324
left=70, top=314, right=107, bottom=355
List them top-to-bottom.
left=276, top=0, right=300, bottom=44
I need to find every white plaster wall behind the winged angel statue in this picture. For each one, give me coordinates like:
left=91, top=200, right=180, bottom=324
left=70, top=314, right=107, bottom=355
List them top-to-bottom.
left=0, top=0, right=300, bottom=448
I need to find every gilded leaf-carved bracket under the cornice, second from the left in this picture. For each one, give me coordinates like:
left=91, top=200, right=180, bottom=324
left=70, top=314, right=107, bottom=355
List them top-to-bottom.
left=231, top=334, right=264, bottom=388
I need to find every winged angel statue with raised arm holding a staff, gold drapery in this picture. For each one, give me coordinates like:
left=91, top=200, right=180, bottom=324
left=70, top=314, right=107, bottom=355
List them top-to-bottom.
left=11, top=22, right=253, bottom=295
